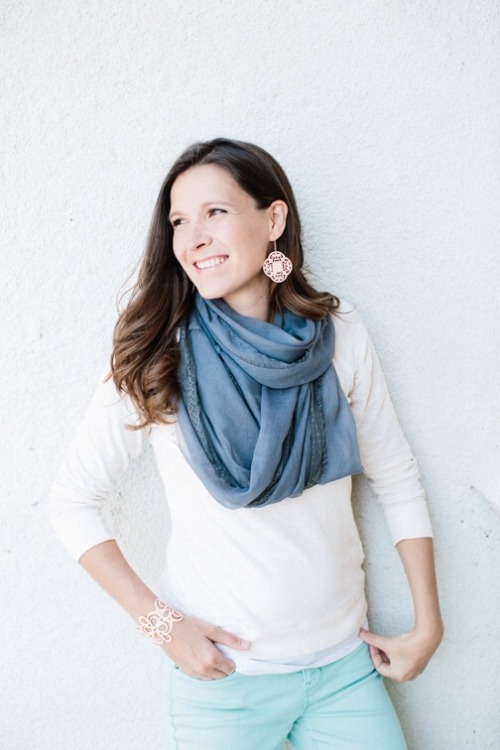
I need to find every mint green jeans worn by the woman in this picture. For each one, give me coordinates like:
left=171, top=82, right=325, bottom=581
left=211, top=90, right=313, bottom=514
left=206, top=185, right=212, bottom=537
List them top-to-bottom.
left=167, top=644, right=406, bottom=750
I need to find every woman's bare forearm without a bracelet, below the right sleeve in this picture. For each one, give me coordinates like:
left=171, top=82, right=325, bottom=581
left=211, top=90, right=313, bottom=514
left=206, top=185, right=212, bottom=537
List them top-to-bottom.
left=396, top=538, right=443, bottom=640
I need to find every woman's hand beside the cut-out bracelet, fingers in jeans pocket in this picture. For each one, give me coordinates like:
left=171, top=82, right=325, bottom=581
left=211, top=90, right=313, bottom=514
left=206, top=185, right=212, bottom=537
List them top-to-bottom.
left=162, top=616, right=251, bottom=680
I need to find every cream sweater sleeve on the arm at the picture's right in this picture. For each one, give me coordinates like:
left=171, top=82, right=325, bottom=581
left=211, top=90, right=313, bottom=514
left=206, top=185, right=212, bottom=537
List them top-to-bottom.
left=349, top=313, right=432, bottom=544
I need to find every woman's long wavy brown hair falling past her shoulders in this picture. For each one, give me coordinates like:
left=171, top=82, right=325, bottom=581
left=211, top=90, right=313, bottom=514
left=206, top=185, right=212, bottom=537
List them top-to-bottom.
left=108, top=138, right=339, bottom=429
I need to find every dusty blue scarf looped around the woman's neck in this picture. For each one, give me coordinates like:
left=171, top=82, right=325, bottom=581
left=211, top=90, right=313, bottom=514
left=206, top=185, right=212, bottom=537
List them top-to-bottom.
left=178, top=294, right=361, bottom=508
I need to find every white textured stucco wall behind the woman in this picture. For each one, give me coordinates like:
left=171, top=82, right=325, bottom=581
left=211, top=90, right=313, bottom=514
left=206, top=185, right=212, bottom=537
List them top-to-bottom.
left=0, top=0, right=500, bottom=750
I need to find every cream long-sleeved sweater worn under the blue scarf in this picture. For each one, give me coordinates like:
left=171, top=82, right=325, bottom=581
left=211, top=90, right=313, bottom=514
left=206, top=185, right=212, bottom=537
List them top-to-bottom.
left=48, top=303, right=432, bottom=673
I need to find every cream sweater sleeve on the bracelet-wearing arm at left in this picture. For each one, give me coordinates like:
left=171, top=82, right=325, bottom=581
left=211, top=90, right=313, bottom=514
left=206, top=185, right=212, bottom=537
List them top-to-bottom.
left=47, top=379, right=148, bottom=560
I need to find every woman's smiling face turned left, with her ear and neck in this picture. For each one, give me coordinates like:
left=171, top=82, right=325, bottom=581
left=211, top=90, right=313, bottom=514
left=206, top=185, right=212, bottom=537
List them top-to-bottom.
left=170, top=164, right=287, bottom=320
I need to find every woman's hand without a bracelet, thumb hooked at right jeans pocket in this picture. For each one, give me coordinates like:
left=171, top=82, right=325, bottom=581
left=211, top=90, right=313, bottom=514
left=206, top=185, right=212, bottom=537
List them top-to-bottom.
left=359, top=626, right=443, bottom=682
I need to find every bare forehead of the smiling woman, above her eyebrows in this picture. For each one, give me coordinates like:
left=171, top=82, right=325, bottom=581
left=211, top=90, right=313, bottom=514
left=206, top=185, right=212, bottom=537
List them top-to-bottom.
left=170, top=164, right=252, bottom=209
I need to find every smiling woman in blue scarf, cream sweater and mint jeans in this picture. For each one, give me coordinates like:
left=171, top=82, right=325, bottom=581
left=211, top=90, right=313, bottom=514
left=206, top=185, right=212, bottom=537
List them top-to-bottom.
left=50, top=138, right=442, bottom=750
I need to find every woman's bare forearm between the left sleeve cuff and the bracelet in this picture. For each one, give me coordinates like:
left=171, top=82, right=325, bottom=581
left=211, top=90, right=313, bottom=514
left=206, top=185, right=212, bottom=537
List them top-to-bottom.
left=79, top=540, right=156, bottom=621
